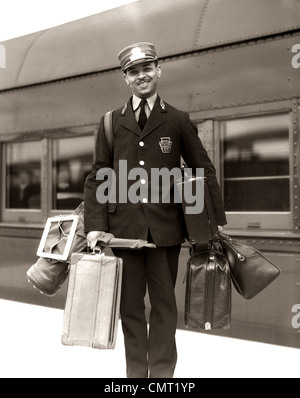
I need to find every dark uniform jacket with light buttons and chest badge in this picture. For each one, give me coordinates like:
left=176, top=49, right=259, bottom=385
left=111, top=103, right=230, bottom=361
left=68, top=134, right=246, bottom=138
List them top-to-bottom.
left=84, top=97, right=226, bottom=246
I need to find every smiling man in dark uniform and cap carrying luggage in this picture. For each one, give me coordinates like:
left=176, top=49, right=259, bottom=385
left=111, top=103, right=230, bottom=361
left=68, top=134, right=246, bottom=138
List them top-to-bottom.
left=84, top=42, right=226, bottom=378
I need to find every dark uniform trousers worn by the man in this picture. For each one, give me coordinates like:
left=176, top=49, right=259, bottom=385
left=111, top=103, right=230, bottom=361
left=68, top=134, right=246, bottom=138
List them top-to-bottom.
left=113, top=245, right=181, bottom=378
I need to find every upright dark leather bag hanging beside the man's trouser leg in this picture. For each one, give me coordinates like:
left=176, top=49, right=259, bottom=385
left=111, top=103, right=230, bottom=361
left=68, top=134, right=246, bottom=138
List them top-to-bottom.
left=185, top=249, right=231, bottom=330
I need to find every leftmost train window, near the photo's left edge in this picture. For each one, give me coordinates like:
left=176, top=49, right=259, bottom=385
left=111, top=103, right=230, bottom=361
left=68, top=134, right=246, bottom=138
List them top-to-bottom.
left=4, top=141, right=41, bottom=210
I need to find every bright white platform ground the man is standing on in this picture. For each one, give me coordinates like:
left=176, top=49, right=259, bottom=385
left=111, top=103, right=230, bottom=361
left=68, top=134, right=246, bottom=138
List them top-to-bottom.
left=0, top=300, right=300, bottom=378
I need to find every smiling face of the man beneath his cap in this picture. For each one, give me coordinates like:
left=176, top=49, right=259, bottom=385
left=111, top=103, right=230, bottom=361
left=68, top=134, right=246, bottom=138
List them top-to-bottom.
left=124, top=62, right=161, bottom=98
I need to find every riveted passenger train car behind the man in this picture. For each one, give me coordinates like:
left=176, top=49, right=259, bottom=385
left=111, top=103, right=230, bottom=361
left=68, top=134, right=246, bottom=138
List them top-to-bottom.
left=0, top=0, right=300, bottom=348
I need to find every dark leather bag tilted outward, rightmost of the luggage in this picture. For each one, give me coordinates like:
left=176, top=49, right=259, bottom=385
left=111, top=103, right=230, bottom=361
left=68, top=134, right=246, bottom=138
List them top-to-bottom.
left=220, top=234, right=281, bottom=300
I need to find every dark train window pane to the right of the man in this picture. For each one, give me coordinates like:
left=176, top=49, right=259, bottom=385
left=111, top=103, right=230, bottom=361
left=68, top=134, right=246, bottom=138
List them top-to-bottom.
left=221, top=114, right=291, bottom=227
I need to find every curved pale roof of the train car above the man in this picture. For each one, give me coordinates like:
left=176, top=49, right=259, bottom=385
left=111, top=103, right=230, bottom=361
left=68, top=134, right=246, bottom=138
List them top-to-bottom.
left=0, top=0, right=300, bottom=90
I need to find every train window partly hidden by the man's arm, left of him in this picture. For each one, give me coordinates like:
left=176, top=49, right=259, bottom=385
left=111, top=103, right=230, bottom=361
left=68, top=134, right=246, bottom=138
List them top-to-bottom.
left=52, top=136, right=94, bottom=210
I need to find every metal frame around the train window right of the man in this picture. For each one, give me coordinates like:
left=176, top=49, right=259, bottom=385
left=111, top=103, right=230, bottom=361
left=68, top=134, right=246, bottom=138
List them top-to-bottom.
left=191, top=98, right=300, bottom=232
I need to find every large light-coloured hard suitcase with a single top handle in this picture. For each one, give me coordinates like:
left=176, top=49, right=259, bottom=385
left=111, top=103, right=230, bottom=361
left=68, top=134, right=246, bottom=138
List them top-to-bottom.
left=62, top=253, right=123, bottom=349
